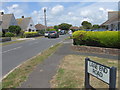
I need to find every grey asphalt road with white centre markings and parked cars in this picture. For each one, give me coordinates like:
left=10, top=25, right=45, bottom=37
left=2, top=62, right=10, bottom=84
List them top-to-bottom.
left=2, top=35, right=68, bottom=78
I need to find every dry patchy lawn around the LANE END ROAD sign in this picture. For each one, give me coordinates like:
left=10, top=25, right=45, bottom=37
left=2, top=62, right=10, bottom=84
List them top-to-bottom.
left=50, top=55, right=118, bottom=88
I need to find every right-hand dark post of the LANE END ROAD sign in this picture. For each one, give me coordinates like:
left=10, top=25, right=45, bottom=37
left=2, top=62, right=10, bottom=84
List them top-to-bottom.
left=109, top=67, right=117, bottom=90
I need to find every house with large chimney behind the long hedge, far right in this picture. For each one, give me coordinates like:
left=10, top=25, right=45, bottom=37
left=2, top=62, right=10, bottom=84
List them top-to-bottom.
left=102, top=11, right=120, bottom=31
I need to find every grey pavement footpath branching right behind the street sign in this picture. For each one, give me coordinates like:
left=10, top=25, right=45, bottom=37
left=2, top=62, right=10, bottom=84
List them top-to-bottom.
left=19, top=40, right=118, bottom=88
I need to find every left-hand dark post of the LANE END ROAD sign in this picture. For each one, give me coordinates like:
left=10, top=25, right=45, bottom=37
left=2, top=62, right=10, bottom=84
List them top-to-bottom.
left=85, top=58, right=90, bottom=88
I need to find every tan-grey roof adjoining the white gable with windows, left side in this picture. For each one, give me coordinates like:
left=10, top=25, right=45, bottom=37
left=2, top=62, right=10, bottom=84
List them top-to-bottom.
left=16, top=17, right=31, bottom=29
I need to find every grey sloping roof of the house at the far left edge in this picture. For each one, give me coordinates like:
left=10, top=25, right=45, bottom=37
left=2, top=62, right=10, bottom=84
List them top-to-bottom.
left=0, top=14, right=14, bottom=29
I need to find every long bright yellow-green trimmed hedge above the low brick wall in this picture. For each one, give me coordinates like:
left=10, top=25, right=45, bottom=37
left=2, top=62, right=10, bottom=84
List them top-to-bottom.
left=73, top=31, right=120, bottom=48
